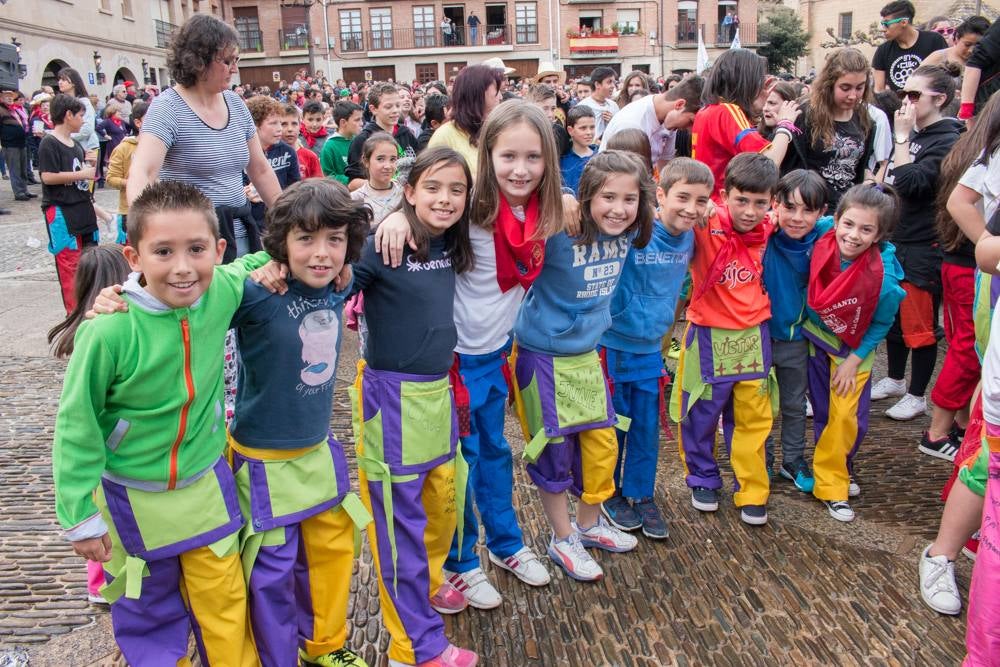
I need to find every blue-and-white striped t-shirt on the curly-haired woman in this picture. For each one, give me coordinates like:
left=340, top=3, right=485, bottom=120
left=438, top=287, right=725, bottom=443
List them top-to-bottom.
left=142, top=88, right=257, bottom=206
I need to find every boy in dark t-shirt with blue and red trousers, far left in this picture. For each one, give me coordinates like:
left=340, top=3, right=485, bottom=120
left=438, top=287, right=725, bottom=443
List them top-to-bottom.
left=38, top=95, right=98, bottom=314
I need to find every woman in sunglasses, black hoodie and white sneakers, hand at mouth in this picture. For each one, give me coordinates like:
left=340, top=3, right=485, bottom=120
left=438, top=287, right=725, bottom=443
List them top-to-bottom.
left=872, top=64, right=968, bottom=426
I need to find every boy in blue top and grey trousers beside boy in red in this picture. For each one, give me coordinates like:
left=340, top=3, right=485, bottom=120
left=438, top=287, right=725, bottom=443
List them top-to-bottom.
left=764, top=169, right=833, bottom=493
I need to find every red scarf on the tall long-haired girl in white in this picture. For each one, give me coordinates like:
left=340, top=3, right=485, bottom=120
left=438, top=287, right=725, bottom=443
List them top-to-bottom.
left=493, top=194, right=545, bottom=292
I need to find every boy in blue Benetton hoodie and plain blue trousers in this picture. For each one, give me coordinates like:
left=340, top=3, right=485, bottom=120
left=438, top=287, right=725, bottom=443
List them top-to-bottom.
left=596, top=159, right=716, bottom=539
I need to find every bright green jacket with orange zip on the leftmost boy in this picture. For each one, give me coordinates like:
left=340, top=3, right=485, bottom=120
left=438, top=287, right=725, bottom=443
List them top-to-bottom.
left=52, top=252, right=269, bottom=541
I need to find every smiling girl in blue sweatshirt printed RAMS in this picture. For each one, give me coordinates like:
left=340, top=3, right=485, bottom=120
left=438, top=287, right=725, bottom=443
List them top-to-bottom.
left=511, top=151, right=653, bottom=581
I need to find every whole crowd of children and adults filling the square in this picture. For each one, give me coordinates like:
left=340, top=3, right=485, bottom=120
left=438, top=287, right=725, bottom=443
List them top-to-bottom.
left=13, top=0, right=1000, bottom=667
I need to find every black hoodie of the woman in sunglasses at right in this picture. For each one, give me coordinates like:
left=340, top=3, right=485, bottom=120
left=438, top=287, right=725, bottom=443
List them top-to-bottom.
left=885, top=118, right=962, bottom=246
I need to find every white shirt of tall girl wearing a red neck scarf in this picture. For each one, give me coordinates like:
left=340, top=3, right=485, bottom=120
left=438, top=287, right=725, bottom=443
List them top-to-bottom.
left=455, top=223, right=524, bottom=354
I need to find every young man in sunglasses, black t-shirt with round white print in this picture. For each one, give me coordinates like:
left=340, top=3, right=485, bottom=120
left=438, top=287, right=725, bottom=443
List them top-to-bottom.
left=872, top=0, right=948, bottom=93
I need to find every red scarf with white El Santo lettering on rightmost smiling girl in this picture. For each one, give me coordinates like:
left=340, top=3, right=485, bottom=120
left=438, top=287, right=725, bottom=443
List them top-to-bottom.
left=808, top=230, right=885, bottom=348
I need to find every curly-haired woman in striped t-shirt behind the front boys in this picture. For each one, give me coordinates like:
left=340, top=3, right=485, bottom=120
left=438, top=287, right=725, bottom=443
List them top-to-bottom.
left=126, top=14, right=281, bottom=262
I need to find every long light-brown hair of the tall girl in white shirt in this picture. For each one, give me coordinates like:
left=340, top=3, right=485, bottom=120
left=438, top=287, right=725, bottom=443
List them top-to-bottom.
left=472, top=100, right=563, bottom=238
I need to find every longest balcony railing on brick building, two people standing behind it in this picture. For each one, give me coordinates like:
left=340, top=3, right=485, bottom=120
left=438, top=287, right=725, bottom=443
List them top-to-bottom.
left=358, top=25, right=513, bottom=53
